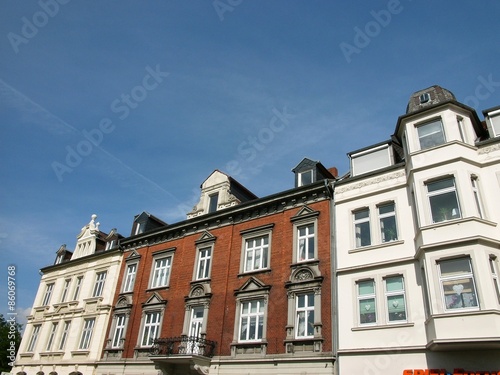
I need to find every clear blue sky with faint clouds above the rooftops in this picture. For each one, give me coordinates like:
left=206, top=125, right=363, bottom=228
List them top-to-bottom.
left=0, top=0, right=500, bottom=328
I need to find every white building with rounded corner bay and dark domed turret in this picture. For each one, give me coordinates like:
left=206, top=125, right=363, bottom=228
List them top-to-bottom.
left=333, top=86, right=500, bottom=375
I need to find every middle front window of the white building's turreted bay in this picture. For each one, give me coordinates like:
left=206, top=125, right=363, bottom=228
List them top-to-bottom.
left=427, top=177, right=461, bottom=223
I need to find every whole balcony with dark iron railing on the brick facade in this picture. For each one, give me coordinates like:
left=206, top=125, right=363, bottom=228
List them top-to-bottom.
left=149, top=336, right=216, bottom=374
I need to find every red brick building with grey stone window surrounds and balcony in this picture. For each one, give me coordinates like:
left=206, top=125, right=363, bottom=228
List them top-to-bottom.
left=96, top=159, right=334, bottom=374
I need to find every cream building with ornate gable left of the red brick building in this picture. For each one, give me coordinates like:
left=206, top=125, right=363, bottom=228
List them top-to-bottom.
left=11, top=215, right=122, bottom=375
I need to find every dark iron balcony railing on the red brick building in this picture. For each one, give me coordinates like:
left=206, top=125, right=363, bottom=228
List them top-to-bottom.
left=150, top=336, right=216, bottom=358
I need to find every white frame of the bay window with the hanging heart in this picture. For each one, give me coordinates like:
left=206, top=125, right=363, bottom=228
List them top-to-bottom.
left=437, top=256, right=479, bottom=312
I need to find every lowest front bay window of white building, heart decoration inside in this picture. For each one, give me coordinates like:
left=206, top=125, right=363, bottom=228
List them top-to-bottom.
left=438, top=257, right=478, bottom=310
